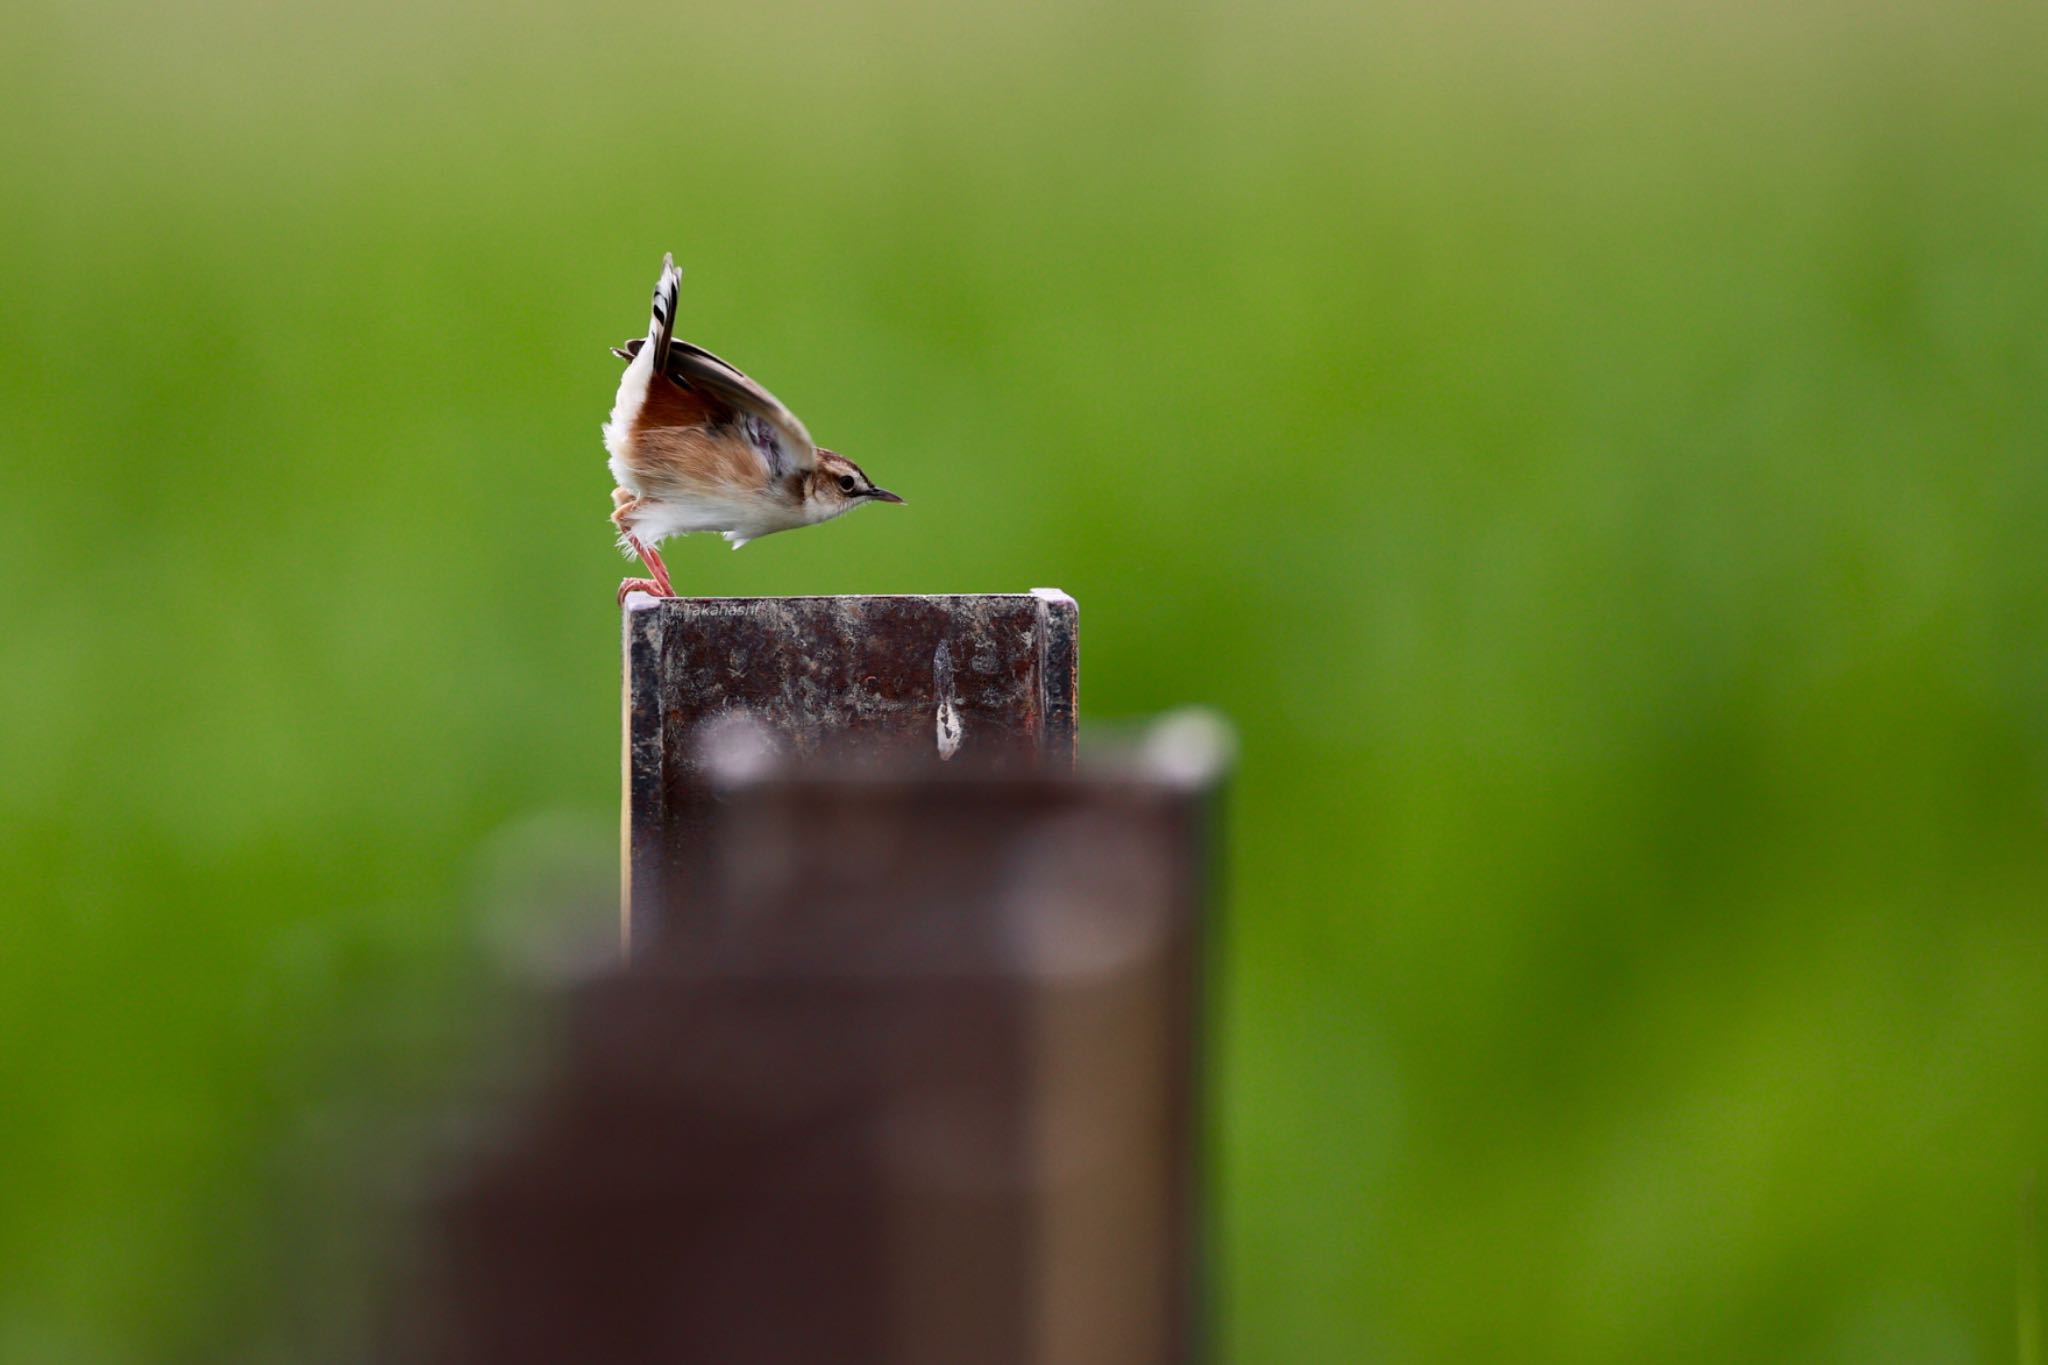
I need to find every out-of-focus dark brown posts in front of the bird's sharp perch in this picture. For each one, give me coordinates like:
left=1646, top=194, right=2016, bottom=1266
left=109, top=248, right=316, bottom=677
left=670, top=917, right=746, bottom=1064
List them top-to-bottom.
left=418, top=716, right=1223, bottom=1365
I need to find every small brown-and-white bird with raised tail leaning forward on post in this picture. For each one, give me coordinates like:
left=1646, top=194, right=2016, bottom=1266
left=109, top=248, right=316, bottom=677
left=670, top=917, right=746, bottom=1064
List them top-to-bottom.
left=604, top=256, right=903, bottom=602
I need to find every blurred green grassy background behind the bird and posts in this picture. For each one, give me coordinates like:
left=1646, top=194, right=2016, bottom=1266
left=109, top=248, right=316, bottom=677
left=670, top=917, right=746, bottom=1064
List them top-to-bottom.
left=0, top=0, right=2048, bottom=1365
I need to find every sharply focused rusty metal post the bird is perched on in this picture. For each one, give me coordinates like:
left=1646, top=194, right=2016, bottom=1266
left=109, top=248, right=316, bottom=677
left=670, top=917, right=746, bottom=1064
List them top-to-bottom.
left=625, top=589, right=1077, bottom=943
